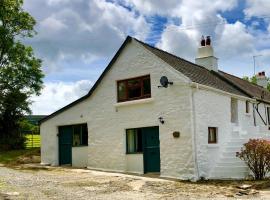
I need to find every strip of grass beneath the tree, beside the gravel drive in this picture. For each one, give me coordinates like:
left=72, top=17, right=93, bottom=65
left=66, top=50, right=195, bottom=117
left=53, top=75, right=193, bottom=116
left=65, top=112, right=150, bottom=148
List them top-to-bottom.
left=0, top=148, right=40, bottom=165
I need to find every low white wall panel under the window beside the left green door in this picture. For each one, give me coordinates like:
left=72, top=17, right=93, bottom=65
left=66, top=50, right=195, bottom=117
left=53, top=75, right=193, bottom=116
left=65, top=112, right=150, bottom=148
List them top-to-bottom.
left=72, top=146, right=88, bottom=167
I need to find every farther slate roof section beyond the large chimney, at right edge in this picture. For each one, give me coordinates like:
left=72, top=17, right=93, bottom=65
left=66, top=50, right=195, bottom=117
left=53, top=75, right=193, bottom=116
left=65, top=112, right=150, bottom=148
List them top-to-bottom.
left=219, top=71, right=270, bottom=103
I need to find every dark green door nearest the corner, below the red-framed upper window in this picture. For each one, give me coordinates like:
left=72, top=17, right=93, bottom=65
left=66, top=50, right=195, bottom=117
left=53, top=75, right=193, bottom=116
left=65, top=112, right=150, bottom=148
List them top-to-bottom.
left=142, top=127, right=160, bottom=173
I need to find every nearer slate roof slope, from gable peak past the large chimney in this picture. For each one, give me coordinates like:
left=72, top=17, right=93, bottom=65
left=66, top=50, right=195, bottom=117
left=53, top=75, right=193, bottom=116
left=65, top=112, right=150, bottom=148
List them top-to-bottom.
left=136, top=40, right=247, bottom=96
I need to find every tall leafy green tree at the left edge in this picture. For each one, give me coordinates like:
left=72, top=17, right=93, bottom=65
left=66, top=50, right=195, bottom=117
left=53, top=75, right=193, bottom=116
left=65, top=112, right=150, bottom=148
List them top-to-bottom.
left=0, top=0, right=44, bottom=149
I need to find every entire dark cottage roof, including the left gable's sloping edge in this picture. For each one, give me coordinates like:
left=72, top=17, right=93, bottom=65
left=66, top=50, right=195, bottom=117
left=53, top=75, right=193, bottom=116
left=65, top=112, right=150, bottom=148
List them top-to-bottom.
left=39, top=36, right=270, bottom=124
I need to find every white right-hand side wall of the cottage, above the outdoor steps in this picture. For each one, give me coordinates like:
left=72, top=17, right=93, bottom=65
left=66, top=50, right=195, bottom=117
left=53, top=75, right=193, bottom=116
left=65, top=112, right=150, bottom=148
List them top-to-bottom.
left=194, top=89, right=269, bottom=178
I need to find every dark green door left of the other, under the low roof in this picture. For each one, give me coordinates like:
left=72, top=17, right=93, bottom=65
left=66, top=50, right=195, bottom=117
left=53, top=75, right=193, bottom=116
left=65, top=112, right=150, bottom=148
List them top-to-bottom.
left=59, top=126, right=72, bottom=165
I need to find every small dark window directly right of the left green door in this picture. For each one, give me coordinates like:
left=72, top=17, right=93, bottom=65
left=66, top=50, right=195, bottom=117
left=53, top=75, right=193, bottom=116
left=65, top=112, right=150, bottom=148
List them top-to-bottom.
left=72, top=124, right=88, bottom=146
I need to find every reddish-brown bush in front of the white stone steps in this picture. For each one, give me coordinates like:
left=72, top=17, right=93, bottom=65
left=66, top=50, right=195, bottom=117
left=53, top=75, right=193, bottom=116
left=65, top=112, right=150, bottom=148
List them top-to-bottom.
left=236, top=139, right=270, bottom=180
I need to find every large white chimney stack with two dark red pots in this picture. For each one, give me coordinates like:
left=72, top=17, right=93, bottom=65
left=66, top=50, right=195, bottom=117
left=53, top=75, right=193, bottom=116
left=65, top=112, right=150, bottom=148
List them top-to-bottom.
left=195, top=36, right=218, bottom=71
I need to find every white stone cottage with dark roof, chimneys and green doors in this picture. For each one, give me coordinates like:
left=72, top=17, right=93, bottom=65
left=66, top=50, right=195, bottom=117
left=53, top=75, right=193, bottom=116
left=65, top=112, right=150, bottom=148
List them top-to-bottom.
left=40, top=37, right=270, bottom=180
